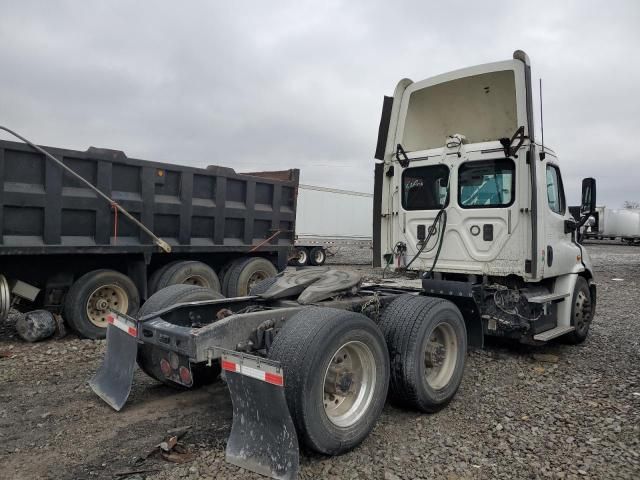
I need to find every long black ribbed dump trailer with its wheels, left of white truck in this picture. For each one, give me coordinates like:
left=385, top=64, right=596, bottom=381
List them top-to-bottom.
left=0, top=135, right=299, bottom=338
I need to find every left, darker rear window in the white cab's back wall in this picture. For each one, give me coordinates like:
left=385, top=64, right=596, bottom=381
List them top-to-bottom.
left=402, top=165, right=449, bottom=210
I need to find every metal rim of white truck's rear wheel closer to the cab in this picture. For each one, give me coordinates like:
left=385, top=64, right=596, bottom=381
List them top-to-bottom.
left=424, top=323, right=458, bottom=390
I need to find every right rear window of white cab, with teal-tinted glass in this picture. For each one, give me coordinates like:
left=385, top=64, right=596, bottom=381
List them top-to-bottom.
left=458, top=158, right=516, bottom=208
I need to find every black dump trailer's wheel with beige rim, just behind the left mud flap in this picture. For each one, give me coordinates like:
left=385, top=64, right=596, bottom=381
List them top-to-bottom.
left=64, top=269, right=140, bottom=340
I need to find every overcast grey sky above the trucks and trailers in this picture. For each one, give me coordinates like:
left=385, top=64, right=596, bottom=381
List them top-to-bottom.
left=0, top=0, right=640, bottom=207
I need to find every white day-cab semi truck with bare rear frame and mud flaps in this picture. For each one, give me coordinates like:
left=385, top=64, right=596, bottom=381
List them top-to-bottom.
left=90, top=51, right=596, bottom=479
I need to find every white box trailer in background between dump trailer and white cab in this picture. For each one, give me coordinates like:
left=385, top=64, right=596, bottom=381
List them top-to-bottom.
left=290, top=184, right=373, bottom=266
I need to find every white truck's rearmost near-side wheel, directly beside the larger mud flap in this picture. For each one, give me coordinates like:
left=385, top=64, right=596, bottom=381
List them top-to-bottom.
left=269, top=307, right=389, bottom=455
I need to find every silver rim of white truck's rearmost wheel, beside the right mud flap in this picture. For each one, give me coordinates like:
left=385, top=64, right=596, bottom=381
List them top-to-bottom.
left=322, top=341, right=376, bottom=428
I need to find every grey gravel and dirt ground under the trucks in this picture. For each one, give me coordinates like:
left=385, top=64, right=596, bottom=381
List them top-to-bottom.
left=0, top=245, right=640, bottom=480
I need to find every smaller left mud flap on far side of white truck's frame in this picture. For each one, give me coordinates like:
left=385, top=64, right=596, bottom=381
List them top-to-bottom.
left=89, top=315, right=138, bottom=411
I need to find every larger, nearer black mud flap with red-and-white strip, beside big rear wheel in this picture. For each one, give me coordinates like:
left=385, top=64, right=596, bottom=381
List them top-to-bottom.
left=220, top=349, right=299, bottom=480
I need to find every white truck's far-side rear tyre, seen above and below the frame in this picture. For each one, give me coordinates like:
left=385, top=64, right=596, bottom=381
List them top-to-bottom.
left=137, top=284, right=224, bottom=389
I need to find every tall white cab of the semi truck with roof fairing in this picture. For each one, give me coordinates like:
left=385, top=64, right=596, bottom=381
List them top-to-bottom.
left=374, top=51, right=595, bottom=343
